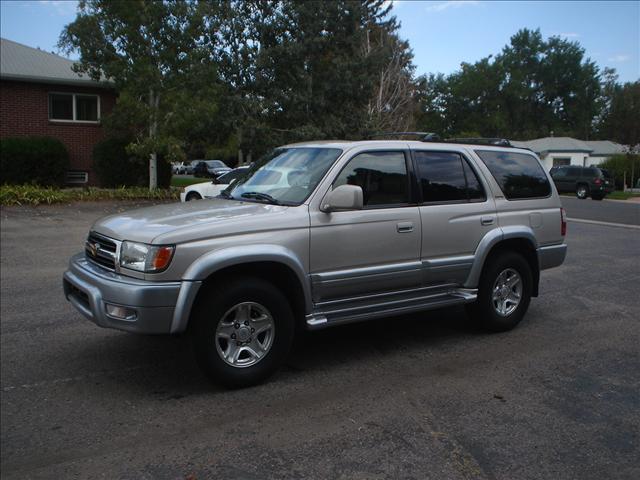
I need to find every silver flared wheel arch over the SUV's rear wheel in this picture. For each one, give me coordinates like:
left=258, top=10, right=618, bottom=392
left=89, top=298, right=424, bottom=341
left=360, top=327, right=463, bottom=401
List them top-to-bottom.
left=464, top=226, right=540, bottom=297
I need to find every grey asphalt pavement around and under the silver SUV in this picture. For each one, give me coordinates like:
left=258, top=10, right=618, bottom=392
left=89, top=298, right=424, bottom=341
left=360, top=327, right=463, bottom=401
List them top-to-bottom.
left=0, top=201, right=640, bottom=479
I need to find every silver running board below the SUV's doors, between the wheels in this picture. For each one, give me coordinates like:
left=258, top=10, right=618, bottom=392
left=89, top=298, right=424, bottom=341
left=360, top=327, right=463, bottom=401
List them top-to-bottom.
left=306, top=288, right=478, bottom=330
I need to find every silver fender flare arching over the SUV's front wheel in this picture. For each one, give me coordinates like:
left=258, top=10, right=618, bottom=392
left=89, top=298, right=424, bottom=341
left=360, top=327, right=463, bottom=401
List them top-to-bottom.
left=171, top=244, right=313, bottom=333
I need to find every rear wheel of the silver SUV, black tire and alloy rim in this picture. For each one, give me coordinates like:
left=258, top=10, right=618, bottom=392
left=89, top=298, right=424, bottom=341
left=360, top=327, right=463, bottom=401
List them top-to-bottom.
left=467, top=252, right=533, bottom=332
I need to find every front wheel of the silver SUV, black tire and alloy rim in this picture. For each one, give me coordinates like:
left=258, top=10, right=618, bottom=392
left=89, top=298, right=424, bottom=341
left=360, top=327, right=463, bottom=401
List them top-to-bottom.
left=191, top=277, right=295, bottom=388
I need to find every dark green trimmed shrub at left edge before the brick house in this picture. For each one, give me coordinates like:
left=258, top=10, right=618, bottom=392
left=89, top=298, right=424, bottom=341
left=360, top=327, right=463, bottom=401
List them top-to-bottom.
left=0, top=137, right=69, bottom=185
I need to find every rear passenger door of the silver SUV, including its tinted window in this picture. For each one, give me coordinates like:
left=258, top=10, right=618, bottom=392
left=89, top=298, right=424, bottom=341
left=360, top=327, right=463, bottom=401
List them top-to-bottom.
left=412, top=149, right=497, bottom=287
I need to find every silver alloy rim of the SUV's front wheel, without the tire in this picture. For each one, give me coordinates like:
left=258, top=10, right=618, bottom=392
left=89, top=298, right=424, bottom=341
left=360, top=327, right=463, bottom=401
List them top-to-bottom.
left=214, top=302, right=275, bottom=368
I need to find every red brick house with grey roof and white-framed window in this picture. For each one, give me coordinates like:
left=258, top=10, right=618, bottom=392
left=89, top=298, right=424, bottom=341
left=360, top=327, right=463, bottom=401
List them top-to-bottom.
left=0, top=38, right=116, bottom=184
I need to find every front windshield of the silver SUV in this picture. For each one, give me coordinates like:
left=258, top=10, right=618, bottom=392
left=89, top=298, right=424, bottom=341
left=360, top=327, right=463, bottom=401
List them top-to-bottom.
left=222, top=147, right=342, bottom=205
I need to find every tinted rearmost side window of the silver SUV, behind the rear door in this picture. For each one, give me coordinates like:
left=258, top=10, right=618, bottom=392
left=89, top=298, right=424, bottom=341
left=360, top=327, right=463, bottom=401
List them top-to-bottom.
left=476, top=150, right=551, bottom=200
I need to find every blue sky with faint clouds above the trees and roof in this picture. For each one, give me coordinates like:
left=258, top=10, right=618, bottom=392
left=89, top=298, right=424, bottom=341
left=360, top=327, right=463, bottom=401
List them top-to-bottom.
left=0, top=0, right=640, bottom=82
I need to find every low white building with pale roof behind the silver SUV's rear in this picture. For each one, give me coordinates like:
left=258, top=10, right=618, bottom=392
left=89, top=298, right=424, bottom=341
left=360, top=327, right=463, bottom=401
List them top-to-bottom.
left=511, top=137, right=624, bottom=170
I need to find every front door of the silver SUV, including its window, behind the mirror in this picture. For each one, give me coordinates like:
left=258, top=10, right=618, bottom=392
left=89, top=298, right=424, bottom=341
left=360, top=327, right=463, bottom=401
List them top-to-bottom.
left=310, top=151, right=421, bottom=303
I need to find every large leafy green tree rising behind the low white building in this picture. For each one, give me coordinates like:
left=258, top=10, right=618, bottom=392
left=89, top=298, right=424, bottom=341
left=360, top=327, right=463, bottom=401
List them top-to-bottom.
left=419, top=29, right=600, bottom=138
